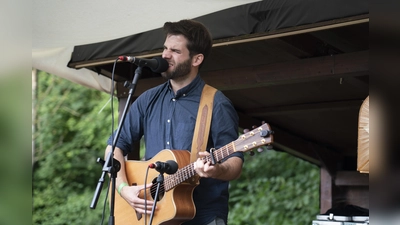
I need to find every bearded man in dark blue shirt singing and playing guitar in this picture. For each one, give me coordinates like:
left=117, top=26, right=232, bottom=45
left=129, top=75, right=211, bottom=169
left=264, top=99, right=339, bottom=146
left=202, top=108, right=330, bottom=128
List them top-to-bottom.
left=106, top=20, right=243, bottom=225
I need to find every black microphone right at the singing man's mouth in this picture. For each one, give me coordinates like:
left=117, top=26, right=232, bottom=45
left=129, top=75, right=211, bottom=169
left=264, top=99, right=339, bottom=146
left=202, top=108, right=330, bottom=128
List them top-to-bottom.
left=118, top=56, right=169, bottom=73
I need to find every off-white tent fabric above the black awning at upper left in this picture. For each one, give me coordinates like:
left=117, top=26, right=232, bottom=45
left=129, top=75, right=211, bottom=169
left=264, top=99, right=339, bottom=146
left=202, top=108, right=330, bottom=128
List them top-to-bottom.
left=32, top=0, right=258, bottom=92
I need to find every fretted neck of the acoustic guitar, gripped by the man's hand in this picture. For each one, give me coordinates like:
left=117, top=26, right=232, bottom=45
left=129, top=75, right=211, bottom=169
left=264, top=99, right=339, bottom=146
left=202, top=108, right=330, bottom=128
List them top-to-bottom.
left=164, top=142, right=235, bottom=191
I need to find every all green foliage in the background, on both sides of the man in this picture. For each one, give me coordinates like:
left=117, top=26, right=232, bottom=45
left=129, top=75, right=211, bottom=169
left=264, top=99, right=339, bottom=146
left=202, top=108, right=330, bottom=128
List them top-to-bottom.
left=32, top=72, right=319, bottom=225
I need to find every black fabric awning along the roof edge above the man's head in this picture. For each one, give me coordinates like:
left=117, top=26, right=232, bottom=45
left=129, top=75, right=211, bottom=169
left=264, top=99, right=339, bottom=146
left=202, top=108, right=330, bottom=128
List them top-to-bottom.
left=68, top=0, right=369, bottom=71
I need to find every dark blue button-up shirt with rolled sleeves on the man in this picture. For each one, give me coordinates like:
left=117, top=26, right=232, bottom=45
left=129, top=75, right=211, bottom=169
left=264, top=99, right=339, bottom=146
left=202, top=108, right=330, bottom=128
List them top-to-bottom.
left=108, top=75, right=243, bottom=224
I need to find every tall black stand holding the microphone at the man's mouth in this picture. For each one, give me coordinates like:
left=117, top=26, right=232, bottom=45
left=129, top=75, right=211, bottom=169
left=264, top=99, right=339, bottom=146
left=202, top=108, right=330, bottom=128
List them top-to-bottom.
left=90, top=66, right=142, bottom=225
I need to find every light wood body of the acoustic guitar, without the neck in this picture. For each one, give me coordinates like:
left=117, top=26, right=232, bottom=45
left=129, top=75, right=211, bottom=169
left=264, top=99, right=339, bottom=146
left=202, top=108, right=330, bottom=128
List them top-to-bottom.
left=115, top=150, right=196, bottom=225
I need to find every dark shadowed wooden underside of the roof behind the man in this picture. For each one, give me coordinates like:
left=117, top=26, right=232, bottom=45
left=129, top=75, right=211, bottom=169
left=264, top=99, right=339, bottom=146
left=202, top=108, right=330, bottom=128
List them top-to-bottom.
left=90, top=15, right=370, bottom=174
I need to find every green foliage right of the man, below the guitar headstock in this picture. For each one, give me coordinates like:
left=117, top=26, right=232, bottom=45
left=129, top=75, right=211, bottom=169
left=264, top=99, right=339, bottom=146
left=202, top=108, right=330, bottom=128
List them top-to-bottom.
left=229, top=150, right=319, bottom=225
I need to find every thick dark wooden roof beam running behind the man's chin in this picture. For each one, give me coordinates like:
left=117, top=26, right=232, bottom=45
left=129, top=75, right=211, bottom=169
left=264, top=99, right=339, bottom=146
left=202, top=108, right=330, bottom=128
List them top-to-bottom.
left=129, top=51, right=369, bottom=95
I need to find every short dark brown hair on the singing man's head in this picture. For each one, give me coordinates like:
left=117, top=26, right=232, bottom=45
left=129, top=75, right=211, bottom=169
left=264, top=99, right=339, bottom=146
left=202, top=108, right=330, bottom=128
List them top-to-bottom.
left=164, top=20, right=212, bottom=60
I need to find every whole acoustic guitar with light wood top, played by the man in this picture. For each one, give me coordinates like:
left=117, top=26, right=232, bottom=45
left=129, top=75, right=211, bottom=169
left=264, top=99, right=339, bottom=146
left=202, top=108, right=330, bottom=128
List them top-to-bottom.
left=115, top=123, right=273, bottom=225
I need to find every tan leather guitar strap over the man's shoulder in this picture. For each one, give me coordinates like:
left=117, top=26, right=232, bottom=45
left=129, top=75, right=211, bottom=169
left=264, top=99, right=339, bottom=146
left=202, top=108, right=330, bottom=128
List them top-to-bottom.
left=190, top=84, right=217, bottom=162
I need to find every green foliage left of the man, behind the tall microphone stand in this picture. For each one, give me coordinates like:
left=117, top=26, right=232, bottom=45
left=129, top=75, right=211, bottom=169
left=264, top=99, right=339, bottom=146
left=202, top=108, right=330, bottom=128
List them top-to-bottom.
left=33, top=72, right=118, bottom=225
